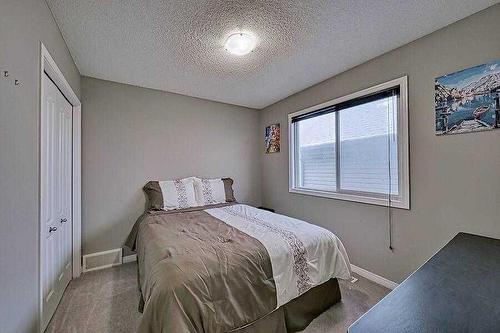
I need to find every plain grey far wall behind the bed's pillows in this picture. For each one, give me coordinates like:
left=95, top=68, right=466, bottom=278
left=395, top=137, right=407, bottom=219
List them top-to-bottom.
left=82, top=77, right=263, bottom=254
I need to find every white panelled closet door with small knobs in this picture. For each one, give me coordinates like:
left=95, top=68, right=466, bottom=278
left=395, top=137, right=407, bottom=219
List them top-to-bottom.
left=40, top=74, right=73, bottom=329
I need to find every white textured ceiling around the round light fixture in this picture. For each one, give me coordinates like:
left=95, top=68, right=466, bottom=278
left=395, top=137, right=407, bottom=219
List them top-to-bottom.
left=47, top=0, right=498, bottom=108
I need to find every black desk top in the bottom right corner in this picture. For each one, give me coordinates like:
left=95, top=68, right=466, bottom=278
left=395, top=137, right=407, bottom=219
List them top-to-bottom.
left=349, top=233, right=500, bottom=333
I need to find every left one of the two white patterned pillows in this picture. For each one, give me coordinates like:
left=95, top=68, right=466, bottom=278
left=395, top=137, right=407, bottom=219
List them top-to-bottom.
left=158, top=177, right=199, bottom=210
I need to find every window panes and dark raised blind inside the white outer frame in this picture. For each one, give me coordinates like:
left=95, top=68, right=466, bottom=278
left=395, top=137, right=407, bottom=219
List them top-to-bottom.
left=291, top=87, right=399, bottom=197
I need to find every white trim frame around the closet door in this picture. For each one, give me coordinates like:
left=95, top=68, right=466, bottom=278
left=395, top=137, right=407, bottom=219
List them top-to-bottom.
left=38, top=42, right=82, bottom=332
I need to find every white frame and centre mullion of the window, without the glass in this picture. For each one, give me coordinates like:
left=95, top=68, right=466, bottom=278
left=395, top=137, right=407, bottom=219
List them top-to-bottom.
left=288, top=76, right=410, bottom=209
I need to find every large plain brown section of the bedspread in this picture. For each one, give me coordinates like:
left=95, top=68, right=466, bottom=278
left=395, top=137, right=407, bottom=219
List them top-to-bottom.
left=137, top=206, right=276, bottom=333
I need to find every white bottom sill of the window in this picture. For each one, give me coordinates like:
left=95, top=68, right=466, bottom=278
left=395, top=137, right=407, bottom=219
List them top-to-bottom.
left=288, top=188, right=410, bottom=210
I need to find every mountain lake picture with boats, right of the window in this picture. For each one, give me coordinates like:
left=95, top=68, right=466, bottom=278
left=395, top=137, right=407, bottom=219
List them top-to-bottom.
left=434, top=60, right=500, bottom=135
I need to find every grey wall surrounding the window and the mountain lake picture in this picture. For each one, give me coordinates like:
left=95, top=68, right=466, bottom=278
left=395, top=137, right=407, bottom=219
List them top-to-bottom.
left=260, top=5, right=500, bottom=282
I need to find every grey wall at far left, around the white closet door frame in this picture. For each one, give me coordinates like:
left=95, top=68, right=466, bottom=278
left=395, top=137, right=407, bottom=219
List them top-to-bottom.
left=0, top=0, right=80, bottom=333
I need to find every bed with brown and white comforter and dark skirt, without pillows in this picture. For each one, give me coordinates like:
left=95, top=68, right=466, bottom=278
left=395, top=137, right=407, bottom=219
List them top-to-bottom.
left=126, top=202, right=351, bottom=333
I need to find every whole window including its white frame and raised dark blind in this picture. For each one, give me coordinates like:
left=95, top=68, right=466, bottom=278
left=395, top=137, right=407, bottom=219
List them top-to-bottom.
left=288, top=77, right=409, bottom=209
